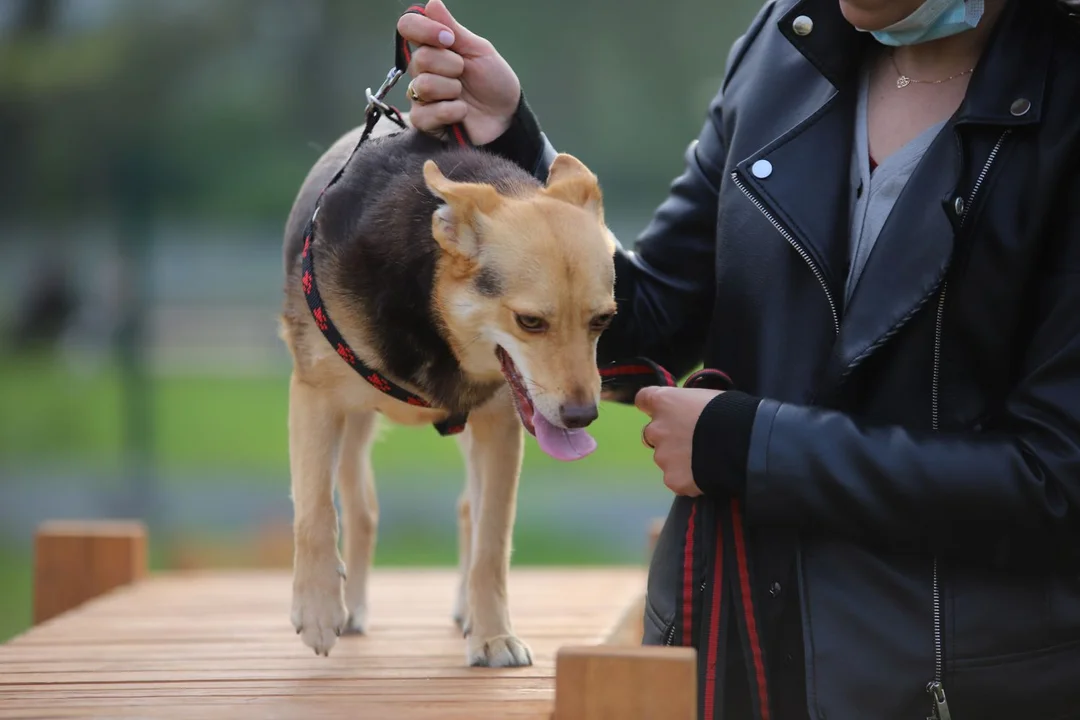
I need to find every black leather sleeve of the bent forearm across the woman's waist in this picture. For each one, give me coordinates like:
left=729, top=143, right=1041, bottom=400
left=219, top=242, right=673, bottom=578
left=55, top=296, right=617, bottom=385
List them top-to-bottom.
left=694, top=173, right=1080, bottom=561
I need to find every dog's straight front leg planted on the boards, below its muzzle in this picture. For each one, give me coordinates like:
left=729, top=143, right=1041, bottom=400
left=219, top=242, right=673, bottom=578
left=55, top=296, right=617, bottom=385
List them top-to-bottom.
left=465, top=391, right=532, bottom=667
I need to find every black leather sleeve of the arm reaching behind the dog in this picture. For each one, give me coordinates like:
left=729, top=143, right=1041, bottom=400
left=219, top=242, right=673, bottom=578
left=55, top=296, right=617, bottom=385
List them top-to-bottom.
left=485, top=9, right=772, bottom=377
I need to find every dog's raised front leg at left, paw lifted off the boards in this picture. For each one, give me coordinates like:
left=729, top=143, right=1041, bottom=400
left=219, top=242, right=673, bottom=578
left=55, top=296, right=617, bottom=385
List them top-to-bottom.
left=288, top=372, right=348, bottom=655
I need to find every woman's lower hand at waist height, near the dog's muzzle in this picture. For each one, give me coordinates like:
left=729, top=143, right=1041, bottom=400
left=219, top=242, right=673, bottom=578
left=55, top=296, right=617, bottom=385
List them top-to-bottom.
left=634, top=388, right=720, bottom=498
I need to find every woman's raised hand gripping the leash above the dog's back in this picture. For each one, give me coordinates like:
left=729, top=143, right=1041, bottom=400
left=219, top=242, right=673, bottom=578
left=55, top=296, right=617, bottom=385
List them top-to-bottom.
left=397, top=0, right=522, bottom=145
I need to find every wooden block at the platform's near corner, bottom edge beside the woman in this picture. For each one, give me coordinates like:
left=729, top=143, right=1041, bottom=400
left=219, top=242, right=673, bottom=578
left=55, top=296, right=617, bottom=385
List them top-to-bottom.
left=552, top=646, right=698, bottom=720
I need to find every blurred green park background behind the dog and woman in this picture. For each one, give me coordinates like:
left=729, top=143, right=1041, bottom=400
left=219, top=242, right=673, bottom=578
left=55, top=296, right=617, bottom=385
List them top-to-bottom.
left=0, top=0, right=760, bottom=641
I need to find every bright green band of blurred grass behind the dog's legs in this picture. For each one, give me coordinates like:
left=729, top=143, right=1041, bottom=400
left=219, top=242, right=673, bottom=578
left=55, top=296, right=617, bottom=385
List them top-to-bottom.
left=0, top=357, right=650, bottom=480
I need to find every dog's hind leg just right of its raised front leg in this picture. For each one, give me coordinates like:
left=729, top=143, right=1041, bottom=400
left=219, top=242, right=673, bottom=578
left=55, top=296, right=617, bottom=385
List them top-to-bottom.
left=337, top=411, right=379, bottom=635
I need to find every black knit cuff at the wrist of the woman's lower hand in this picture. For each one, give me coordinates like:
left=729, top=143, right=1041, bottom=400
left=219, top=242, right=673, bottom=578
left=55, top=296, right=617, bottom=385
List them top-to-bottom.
left=690, top=390, right=761, bottom=497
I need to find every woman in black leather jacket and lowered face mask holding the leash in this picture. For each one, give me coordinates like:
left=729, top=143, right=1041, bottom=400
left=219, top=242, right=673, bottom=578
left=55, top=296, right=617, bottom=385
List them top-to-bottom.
left=399, top=0, right=1080, bottom=720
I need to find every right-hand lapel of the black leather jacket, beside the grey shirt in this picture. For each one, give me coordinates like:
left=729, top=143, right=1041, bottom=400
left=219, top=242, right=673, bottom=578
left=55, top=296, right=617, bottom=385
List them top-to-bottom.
left=820, top=0, right=1050, bottom=393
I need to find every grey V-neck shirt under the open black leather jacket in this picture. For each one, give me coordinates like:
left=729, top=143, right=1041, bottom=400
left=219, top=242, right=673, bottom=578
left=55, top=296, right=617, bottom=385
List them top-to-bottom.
left=845, top=62, right=945, bottom=304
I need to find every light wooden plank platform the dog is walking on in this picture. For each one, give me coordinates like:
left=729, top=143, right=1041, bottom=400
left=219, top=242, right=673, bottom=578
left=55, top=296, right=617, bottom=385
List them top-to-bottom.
left=0, top=524, right=693, bottom=720
